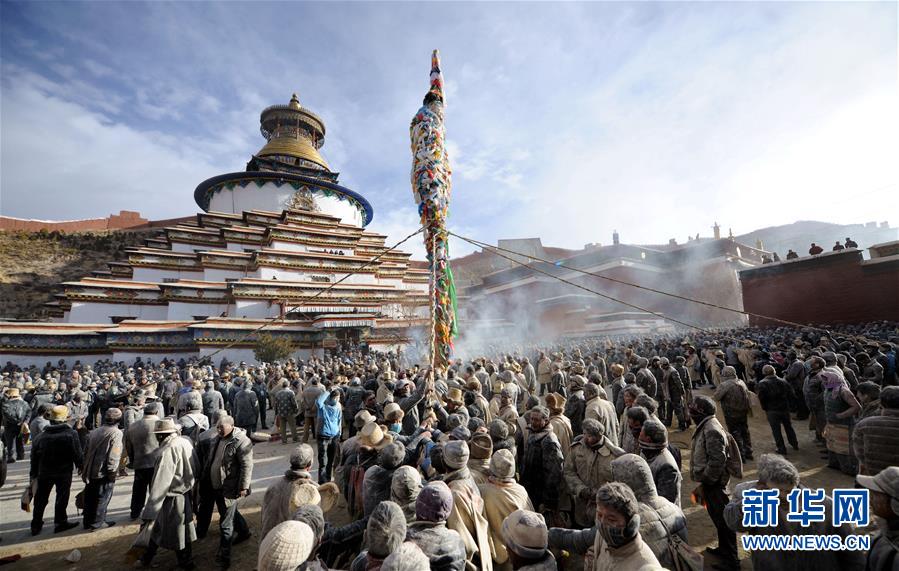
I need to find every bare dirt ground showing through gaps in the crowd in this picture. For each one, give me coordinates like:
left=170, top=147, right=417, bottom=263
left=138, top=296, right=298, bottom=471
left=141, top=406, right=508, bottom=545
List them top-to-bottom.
left=0, top=390, right=853, bottom=571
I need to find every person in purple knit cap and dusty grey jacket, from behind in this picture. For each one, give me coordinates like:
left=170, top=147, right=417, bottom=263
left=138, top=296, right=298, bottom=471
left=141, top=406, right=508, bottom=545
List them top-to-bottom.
left=406, top=480, right=466, bottom=571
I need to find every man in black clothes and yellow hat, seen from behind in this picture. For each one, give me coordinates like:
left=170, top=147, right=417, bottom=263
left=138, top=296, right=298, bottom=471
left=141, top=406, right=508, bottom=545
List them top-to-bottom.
left=29, top=405, right=83, bottom=535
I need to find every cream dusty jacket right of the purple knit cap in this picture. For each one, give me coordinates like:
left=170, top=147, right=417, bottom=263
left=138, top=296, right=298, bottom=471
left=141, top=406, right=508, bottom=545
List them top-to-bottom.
left=443, top=467, right=493, bottom=571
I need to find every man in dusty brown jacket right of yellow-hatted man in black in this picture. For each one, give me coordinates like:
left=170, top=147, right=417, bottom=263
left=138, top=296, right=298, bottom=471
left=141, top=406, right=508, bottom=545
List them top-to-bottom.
left=81, top=408, right=122, bottom=531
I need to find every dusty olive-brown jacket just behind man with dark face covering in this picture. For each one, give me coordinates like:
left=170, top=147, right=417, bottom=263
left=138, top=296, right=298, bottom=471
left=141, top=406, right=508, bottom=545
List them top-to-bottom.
left=563, top=436, right=624, bottom=526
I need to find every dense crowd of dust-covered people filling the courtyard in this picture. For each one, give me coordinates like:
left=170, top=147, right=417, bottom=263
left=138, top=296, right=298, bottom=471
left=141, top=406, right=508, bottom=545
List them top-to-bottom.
left=0, top=322, right=899, bottom=571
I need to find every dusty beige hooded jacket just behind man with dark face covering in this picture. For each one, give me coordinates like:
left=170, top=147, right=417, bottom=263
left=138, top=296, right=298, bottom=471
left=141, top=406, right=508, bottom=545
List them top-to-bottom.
left=612, top=454, right=687, bottom=568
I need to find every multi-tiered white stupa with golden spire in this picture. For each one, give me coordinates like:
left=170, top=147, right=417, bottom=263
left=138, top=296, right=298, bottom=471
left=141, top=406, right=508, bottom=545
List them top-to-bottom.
left=0, top=95, right=429, bottom=365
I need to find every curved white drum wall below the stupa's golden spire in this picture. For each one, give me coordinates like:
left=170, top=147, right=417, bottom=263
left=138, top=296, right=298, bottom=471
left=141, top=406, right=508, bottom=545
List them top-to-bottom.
left=209, top=182, right=362, bottom=227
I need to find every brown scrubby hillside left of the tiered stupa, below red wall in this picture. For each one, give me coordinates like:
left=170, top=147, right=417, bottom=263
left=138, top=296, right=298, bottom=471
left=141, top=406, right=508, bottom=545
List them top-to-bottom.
left=0, top=230, right=157, bottom=319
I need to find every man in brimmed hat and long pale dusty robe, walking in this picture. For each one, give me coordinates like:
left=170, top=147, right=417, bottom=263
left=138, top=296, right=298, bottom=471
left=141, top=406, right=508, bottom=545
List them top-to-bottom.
left=137, top=418, right=196, bottom=569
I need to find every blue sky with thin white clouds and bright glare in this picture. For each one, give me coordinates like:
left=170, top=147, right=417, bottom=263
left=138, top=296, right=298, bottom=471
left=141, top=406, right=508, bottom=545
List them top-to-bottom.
left=0, top=2, right=899, bottom=260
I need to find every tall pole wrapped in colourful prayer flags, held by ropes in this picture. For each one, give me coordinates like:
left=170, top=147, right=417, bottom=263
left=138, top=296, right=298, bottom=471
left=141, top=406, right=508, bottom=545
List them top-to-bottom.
left=409, top=50, right=457, bottom=370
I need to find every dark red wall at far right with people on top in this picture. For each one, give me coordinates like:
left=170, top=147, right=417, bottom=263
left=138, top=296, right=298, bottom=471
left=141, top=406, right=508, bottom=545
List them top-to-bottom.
left=740, top=250, right=899, bottom=325
